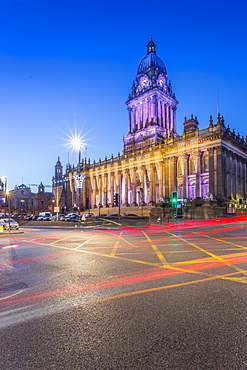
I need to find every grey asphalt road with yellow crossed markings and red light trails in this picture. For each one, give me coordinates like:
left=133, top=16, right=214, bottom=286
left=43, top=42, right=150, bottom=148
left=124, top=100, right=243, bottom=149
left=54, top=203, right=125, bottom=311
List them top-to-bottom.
left=0, top=217, right=247, bottom=370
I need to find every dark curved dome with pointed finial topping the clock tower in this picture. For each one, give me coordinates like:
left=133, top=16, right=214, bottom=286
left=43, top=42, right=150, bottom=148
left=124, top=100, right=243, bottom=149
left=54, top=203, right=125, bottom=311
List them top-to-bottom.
left=137, top=36, right=167, bottom=75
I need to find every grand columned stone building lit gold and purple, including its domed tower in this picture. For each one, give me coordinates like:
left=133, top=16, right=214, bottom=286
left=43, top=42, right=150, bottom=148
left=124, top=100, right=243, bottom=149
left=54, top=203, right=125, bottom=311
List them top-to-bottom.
left=53, top=39, right=247, bottom=209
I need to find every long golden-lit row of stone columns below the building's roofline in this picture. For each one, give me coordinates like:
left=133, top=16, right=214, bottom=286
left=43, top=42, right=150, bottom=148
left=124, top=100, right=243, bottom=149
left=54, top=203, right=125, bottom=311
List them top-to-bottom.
left=67, top=147, right=247, bottom=208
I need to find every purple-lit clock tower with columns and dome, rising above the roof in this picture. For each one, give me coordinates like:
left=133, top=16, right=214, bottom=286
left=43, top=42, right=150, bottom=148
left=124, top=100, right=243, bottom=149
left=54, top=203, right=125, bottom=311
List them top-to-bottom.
left=124, top=36, right=178, bottom=153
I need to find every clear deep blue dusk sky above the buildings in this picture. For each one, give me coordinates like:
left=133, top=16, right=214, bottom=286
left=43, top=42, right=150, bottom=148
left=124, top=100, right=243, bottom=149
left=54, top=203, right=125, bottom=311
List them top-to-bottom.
left=0, top=0, right=247, bottom=192
